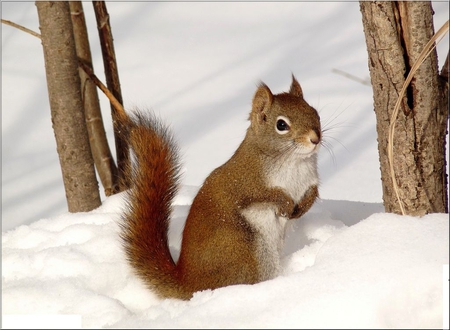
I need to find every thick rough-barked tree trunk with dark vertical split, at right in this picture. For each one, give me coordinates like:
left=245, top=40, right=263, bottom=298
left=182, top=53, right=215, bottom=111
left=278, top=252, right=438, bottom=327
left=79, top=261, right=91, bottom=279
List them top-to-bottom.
left=360, top=1, right=448, bottom=216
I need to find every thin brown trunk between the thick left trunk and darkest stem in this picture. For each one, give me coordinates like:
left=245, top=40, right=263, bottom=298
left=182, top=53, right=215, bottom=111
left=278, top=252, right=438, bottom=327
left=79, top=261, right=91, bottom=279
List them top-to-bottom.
left=69, top=1, right=117, bottom=196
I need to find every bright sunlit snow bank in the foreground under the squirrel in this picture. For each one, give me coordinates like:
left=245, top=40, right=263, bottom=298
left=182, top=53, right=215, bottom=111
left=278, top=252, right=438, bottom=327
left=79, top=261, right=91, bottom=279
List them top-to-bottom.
left=2, top=189, right=449, bottom=328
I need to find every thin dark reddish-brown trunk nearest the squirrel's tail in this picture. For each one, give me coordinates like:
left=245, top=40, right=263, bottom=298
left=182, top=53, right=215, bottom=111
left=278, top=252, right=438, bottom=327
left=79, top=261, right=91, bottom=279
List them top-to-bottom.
left=92, top=1, right=129, bottom=191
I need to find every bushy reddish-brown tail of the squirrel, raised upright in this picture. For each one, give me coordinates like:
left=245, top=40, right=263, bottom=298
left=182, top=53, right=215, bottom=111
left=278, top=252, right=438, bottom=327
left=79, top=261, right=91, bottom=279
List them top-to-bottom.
left=119, top=110, right=190, bottom=298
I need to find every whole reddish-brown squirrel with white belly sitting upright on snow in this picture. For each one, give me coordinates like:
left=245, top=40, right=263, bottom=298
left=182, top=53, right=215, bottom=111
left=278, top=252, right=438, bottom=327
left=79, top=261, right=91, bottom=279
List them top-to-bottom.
left=118, top=75, right=322, bottom=300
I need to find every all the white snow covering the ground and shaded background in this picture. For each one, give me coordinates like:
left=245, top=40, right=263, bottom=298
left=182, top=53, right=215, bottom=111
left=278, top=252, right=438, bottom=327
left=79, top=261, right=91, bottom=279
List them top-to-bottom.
left=2, top=1, right=449, bottom=328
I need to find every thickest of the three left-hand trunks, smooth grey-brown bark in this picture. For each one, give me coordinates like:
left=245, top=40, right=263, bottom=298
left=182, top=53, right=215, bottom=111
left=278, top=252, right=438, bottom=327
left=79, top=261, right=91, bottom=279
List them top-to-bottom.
left=36, top=1, right=101, bottom=212
